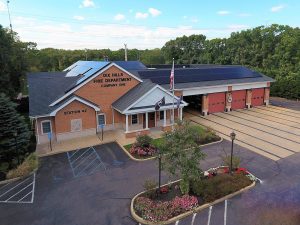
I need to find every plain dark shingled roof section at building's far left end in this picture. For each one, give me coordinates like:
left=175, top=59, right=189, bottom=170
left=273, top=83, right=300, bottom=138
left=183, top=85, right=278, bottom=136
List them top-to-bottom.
left=27, top=72, right=78, bottom=116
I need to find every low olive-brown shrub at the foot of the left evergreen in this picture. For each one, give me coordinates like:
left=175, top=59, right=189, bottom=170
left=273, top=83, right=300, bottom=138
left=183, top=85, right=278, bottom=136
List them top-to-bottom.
left=6, top=153, right=38, bottom=179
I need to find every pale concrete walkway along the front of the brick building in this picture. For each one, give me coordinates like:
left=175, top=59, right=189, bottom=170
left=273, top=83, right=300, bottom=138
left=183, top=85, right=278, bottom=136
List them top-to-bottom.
left=36, top=128, right=163, bottom=156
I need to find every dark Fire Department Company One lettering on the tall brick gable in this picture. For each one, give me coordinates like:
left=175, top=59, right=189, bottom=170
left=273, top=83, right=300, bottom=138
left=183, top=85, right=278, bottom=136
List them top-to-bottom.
left=94, top=73, right=131, bottom=87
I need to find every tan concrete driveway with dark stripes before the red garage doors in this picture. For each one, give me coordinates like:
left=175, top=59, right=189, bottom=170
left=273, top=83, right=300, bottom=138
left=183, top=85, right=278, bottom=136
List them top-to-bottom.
left=189, top=106, right=300, bottom=161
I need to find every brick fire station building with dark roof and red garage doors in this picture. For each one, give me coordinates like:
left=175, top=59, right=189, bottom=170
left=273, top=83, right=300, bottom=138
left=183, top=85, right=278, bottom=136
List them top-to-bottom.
left=28, top=61, right=274, bottom=143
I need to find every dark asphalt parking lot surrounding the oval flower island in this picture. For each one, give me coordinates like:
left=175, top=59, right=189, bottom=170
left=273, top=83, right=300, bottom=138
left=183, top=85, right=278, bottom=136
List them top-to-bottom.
left=0, top=140, right=300, bottom=225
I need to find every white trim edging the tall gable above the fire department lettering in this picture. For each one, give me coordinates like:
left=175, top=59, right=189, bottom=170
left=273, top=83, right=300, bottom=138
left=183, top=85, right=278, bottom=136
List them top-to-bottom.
left=49, top=63, right=143, bottom=106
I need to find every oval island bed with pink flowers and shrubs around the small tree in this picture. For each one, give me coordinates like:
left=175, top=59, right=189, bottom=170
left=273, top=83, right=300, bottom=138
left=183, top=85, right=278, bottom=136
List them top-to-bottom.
left=132, top=167, right=256, bottom=224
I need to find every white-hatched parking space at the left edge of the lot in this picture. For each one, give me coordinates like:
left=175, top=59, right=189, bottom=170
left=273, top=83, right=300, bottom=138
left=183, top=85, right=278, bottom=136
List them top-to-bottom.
left=0, top=173, right=35, bottom=204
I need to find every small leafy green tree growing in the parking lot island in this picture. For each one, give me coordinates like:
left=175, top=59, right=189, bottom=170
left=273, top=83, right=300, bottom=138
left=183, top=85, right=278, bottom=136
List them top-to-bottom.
left=160, top=121, right=205, bottom=194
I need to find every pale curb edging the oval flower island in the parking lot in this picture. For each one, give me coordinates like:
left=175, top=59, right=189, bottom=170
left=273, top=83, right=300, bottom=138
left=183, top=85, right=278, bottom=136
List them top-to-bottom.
left=130, top=176, right=256, bottom=225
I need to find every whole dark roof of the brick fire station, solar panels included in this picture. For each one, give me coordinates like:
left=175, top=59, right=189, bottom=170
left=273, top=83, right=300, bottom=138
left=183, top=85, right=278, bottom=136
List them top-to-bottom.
left=27, top=61, right=274, bottom=116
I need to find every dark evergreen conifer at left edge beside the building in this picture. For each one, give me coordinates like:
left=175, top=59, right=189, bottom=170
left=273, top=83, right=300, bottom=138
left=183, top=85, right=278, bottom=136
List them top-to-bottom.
left=0, top=93, right=30, bottom=169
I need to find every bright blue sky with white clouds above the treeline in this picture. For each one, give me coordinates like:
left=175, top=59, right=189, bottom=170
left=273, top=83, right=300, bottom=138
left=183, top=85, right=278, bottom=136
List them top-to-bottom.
left=0, top=0, right=300, bottom=50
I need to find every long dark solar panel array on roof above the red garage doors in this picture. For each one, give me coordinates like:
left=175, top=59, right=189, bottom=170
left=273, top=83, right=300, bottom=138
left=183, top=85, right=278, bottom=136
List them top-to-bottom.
left=138, top=66, right=262, bottom=84
